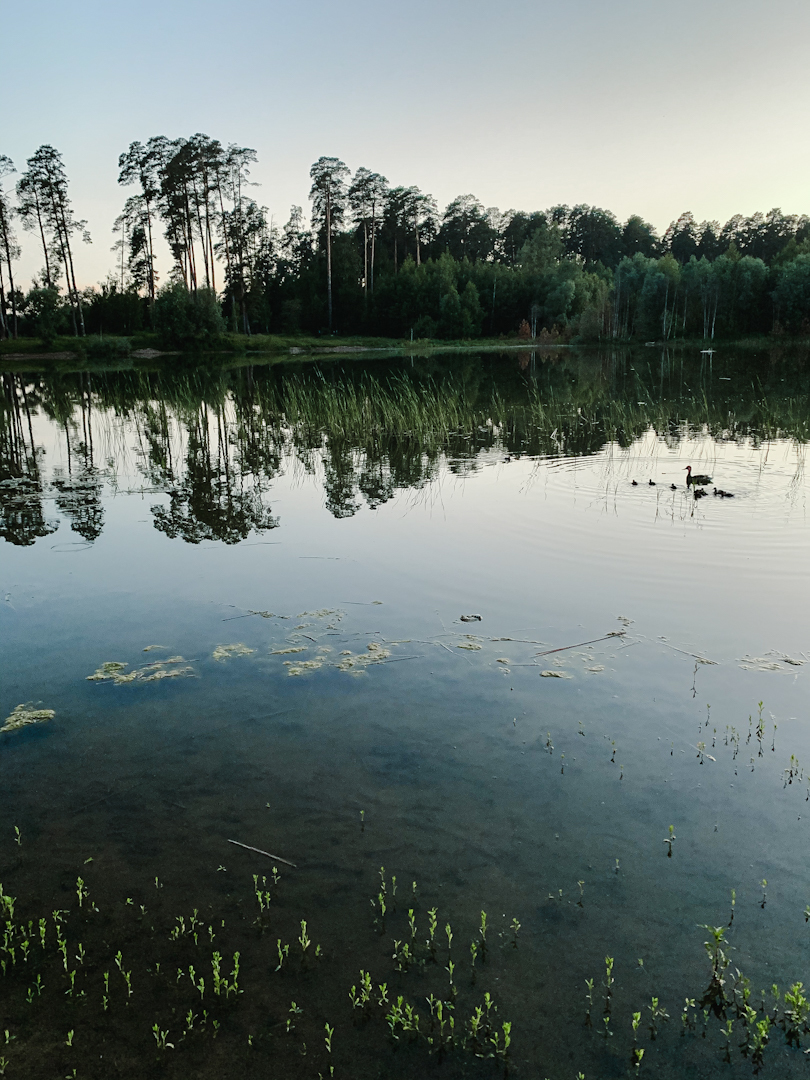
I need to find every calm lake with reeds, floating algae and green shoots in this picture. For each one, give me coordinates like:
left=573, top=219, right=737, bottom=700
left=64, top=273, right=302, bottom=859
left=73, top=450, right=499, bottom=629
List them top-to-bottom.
left=0, top=348, right=810, bottom=1080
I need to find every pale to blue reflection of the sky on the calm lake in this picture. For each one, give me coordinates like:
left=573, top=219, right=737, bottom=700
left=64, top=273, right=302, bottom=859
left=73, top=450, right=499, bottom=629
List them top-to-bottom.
left=0, top=352, right=810, bottom=1076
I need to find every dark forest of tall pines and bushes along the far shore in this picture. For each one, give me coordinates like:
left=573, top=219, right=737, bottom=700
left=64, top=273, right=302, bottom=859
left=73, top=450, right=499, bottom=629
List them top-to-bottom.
left=0, top=134, right=810, bottom=346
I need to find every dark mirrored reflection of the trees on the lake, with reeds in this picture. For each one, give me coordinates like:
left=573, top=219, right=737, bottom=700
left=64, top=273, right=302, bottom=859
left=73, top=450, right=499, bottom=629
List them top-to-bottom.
left=0, top=350, right=810, bottom=545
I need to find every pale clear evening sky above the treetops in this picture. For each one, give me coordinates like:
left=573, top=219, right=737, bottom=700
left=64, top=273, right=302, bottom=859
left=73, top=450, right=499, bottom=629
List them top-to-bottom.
left=0, top=0, right=810, bottom=285
